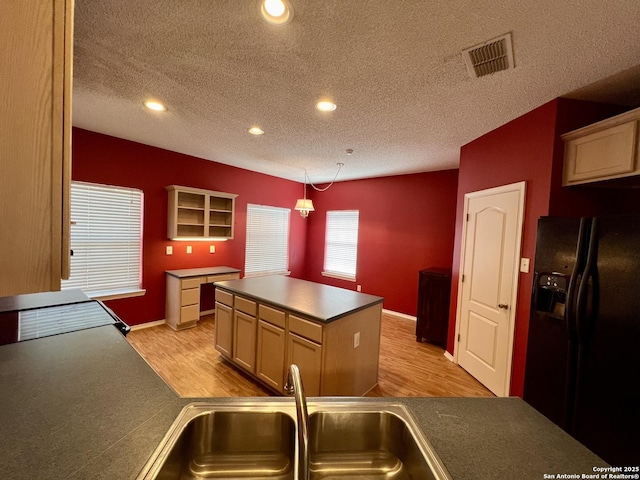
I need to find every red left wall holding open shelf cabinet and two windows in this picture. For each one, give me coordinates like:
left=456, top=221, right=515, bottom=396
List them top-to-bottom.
left=72, top=128, right=306, bottom=325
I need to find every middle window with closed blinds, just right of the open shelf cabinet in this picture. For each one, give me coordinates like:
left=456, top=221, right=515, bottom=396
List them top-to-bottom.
left=244, top=204, right=291, bottom=277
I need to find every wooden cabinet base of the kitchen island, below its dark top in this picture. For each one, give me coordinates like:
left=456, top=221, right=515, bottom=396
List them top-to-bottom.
left=215, top=282, right=382, bottom=397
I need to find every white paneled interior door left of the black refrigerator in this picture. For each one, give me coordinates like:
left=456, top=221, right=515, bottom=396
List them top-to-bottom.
left=455, top=182, right=525, bottom=396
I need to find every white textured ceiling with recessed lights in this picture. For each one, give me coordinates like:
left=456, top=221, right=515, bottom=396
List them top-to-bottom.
left=73, top=0, right=640, bottom=183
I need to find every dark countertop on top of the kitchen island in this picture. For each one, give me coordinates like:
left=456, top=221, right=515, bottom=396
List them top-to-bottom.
left=215, top=275, right=384, bottom=323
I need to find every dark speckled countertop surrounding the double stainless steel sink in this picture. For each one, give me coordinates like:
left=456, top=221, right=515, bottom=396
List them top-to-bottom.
left=0, top=326, right=604, bottom=480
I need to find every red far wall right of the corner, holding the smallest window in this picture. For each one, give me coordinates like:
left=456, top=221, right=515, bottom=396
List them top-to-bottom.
left=305, top=170, right=458, bottom=316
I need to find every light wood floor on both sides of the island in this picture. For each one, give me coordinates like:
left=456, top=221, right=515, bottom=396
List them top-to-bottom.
left=127, top=314, right=493, bottom=397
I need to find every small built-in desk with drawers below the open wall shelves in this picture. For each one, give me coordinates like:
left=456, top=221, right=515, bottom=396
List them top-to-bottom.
left=165, top=267, right=240, bottom=330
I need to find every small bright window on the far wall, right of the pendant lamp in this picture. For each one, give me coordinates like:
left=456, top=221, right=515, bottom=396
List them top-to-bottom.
left=322, top=210, right=359, bottom=281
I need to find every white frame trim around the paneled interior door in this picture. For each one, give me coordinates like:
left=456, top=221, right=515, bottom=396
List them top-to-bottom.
left=453, top=181, right=527, bottom=397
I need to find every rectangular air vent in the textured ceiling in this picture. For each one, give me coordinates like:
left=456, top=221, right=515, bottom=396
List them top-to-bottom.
left=462, top=33, right=513, bottom=78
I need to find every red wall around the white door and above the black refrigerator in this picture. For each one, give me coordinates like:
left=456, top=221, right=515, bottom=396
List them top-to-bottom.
left=447, top=99, right=637, bottom=396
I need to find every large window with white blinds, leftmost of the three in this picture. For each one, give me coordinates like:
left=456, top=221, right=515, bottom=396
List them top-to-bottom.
left=62, top=182, right=143, bottom=298
